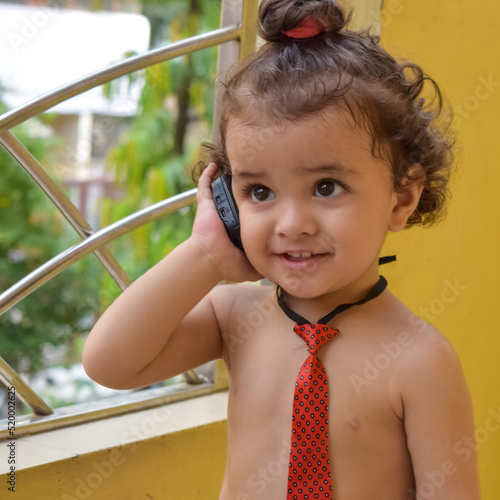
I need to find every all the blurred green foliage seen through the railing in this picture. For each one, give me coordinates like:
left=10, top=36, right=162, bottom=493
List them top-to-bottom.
left=0, top=0, right=220, bottom=378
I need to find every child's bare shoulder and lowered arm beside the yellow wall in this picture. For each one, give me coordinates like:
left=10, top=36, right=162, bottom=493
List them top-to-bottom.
left=378, top=299, right=479, bottom=500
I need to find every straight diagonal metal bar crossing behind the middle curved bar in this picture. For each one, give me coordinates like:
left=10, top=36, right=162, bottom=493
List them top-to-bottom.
left=0, top=132, right=132, bottom=290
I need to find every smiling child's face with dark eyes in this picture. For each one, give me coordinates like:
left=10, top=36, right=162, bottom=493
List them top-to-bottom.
left=226, top=109, right=397, bottom=298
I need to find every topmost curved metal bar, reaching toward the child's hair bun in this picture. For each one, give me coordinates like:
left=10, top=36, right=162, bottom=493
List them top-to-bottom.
left=0, top=25, right=241, bottom=134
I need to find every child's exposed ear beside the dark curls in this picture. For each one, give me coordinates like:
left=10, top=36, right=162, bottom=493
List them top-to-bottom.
left=388, top=164, right=425, bottom=233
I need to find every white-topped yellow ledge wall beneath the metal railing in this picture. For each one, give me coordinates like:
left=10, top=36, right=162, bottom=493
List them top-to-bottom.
left=0, top=392, right=227, bottom=500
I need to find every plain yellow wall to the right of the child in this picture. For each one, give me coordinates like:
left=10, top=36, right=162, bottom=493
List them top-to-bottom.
left=381, top=0, right=500, bottom=500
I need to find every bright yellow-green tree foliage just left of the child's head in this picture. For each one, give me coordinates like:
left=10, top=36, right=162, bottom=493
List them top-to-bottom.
left=102, top=0, right=219, bottom=278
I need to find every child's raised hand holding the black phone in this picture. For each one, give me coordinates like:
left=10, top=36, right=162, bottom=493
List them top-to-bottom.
left=191, top=163, right=262, bottom=282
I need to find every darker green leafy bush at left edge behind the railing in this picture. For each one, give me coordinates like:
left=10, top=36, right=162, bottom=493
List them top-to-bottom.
left=0, top=110, right=102, bottom=371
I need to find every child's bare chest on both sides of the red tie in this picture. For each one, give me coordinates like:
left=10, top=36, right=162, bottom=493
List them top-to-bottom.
left=226, top=318, right=412, bottom=500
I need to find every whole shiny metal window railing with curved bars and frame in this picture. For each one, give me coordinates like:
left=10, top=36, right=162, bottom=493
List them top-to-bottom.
left=0, top=0, right=258, bottom=439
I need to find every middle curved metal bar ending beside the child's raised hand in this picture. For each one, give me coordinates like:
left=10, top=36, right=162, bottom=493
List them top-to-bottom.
left=0, top=188, right=197, bottom=314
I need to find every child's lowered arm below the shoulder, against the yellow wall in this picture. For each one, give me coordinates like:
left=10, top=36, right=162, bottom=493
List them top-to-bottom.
left=401, top=332, right=480, bottom=500
